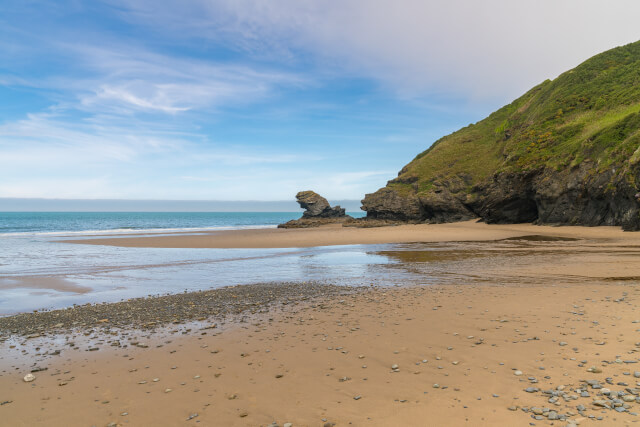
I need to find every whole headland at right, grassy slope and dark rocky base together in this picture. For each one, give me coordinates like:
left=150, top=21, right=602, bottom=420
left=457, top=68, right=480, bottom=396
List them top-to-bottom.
left=362, top=42, right=640, bottom=230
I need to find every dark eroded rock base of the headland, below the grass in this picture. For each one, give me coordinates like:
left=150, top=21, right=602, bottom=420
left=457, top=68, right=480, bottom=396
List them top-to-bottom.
left=362, top=161, right=640, bottom=231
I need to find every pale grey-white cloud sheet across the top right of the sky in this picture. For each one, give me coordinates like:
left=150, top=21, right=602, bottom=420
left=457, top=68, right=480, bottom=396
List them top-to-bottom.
left=112, top=0, right=640, bottom=99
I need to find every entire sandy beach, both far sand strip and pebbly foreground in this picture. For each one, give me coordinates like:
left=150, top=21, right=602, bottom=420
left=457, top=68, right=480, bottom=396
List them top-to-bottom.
left=0, top=222, right=640, bottom=426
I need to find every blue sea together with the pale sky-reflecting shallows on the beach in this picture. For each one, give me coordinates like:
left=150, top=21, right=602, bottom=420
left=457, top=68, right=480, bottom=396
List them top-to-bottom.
left=0, top=212, right=440, bottom=315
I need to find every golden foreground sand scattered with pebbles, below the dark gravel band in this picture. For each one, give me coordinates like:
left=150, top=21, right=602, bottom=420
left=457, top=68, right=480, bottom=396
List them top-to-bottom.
left=0, top=284, right=640, bottom=426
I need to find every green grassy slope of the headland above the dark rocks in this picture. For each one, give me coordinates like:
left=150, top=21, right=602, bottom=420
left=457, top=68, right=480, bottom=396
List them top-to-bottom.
left=388, top=42, right=640, bottom=195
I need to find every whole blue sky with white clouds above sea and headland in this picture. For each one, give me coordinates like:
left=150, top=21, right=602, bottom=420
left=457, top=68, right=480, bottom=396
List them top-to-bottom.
left=0, top=0, right=640, bottom=200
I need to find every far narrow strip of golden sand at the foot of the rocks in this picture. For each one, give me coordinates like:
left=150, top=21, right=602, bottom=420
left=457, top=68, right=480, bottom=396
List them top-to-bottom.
left=61, top=221, right=640, bottom=248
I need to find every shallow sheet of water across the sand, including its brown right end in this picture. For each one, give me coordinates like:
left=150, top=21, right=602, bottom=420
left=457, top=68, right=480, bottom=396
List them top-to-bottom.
left=0, top=231, right=616, bottom=315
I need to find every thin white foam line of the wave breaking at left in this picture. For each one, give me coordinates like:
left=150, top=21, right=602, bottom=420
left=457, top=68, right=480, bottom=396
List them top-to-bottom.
left=0, top=224, right=277, bottom=237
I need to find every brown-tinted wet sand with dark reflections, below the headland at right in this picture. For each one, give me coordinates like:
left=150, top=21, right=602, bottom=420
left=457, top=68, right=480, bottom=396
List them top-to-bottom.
left=374, top=235, right=640, bottom=284
